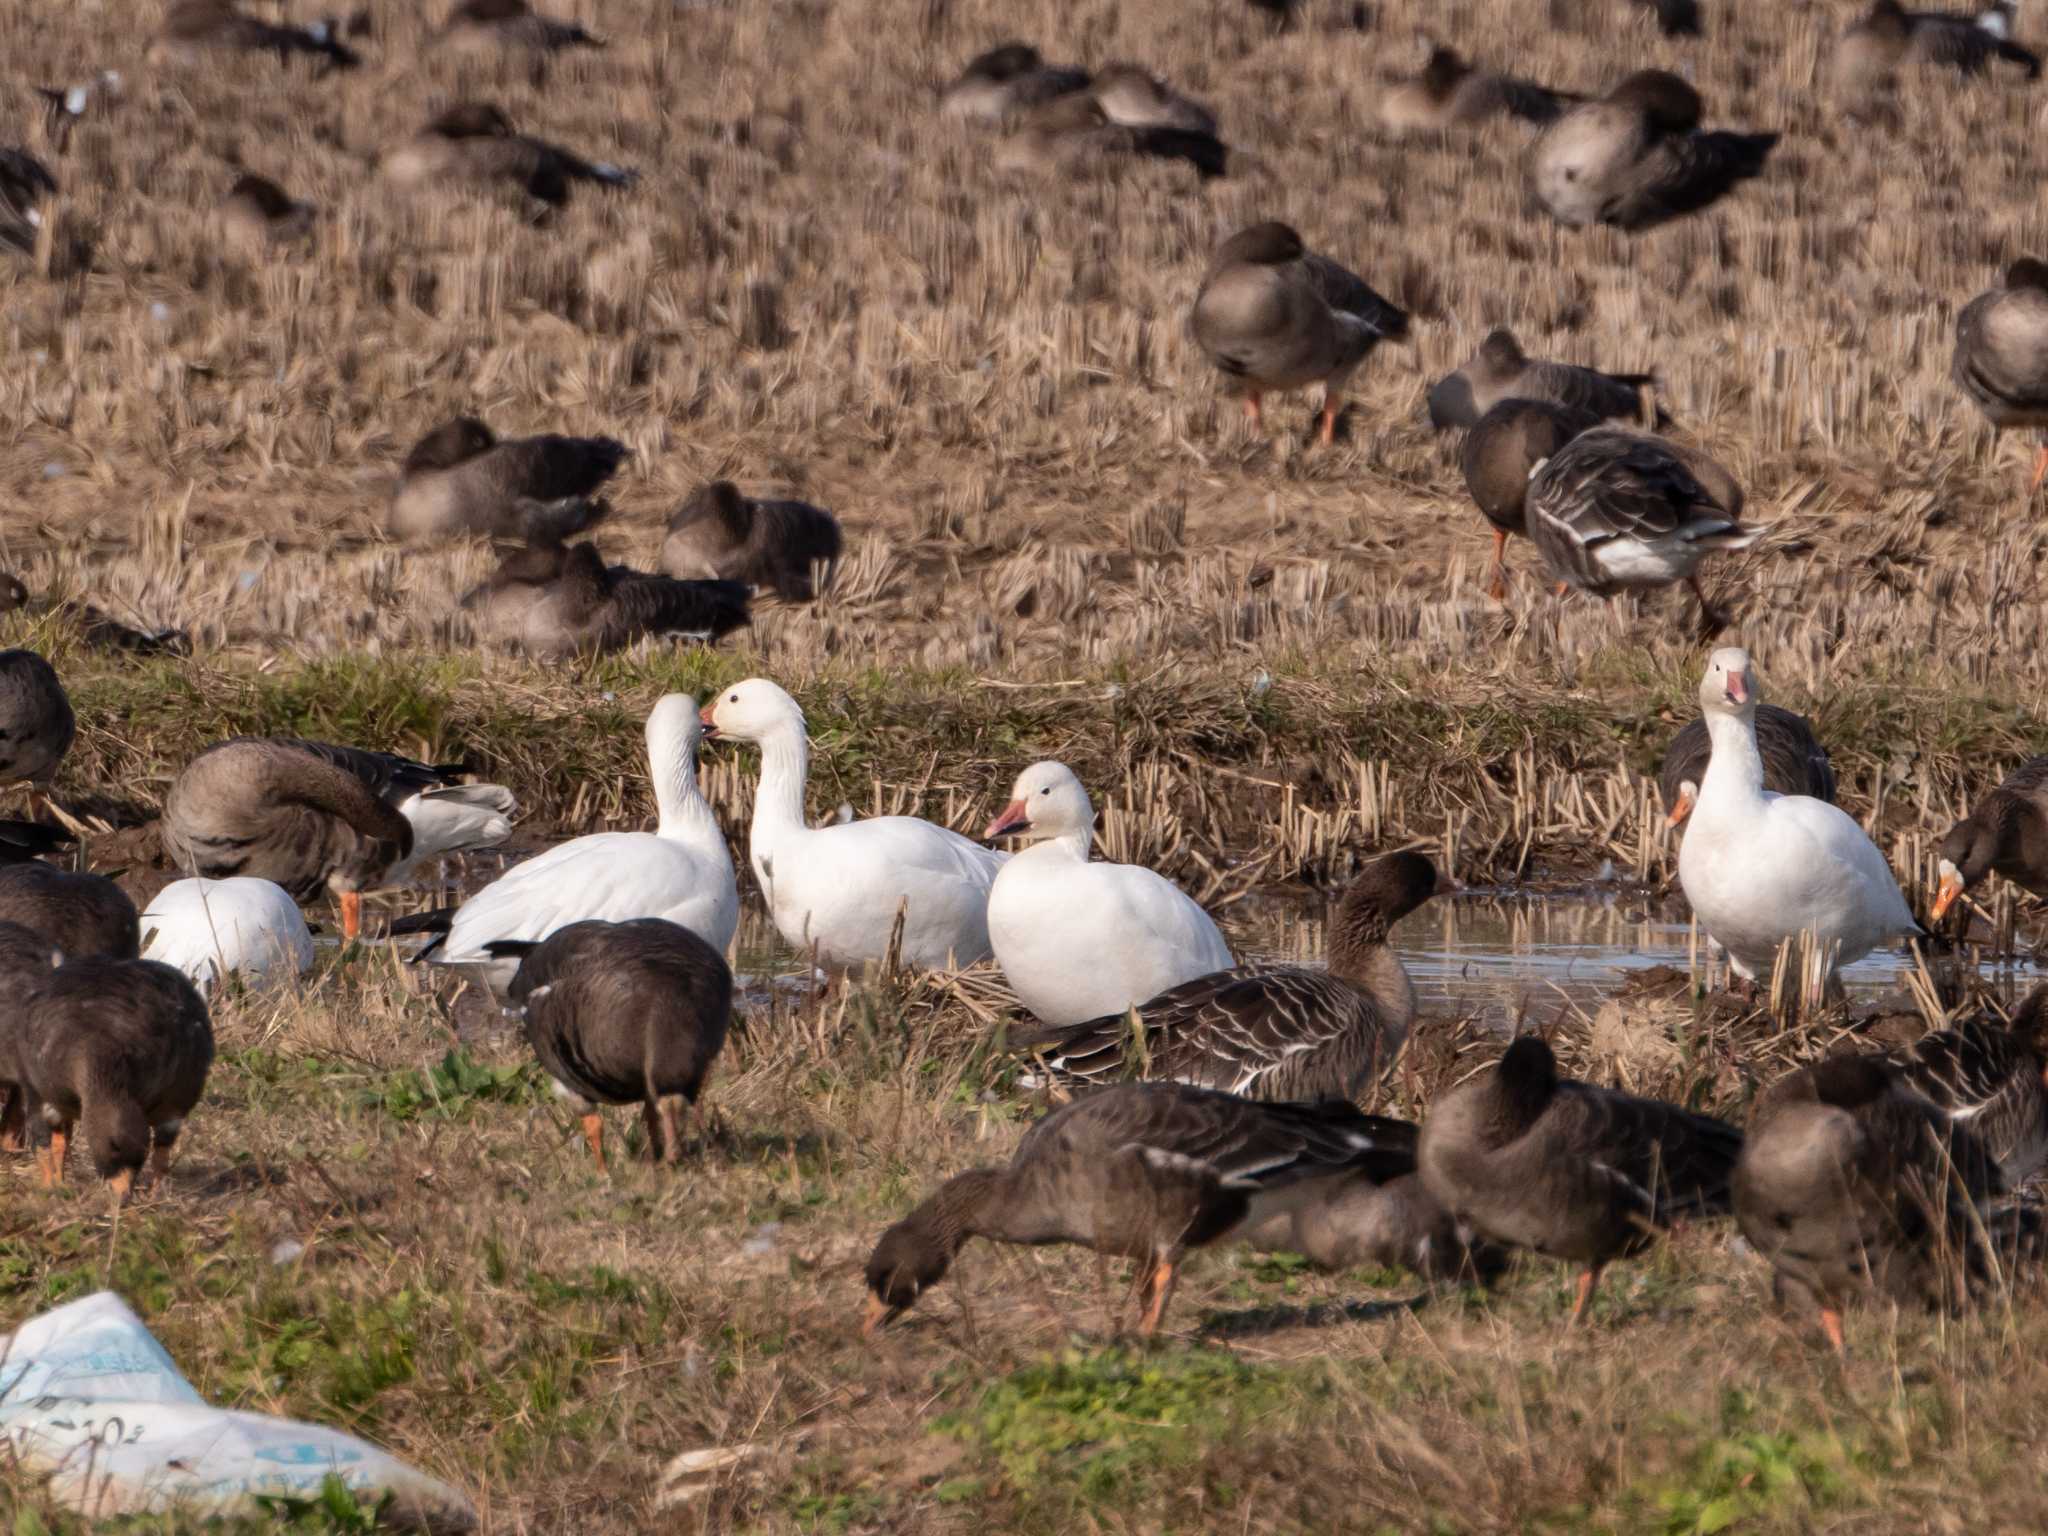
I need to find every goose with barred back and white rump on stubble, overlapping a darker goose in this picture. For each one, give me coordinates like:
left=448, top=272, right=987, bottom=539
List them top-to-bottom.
left=1524, top=426, right=1763, bottom=631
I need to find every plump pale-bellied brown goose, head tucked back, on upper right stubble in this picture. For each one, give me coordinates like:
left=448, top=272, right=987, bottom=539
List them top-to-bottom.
left=1530, top=70, right=1778, bottom=229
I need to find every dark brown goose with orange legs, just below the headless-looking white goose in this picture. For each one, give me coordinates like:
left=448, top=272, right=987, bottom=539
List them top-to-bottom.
left=18, top=956, right=213, bottom=1200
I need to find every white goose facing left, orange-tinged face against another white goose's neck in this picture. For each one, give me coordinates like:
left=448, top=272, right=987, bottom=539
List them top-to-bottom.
left=705, top=678, right=1006, bottom=971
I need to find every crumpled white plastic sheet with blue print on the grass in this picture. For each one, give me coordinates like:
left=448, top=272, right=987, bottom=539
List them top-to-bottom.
left=0, top=1290, right=475, bottom=1532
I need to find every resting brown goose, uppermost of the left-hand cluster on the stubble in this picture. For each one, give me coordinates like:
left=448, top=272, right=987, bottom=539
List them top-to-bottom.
left=385, top=416, right=629, bottom=543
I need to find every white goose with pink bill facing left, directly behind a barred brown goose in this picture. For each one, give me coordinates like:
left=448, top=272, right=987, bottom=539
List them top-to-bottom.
left=985, top=762, right=1237, bottom=1024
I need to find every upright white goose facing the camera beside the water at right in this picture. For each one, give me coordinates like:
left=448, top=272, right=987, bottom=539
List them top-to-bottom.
left=1677, top=645, right=1921, bottom=981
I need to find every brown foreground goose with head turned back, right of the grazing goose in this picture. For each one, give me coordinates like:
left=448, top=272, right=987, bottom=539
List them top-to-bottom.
left=1415, top=1034, right=1743, bottom=1323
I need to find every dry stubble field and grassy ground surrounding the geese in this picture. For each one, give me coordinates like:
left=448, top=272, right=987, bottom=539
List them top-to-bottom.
left=0, top=0, right=2048, bottom=1532
